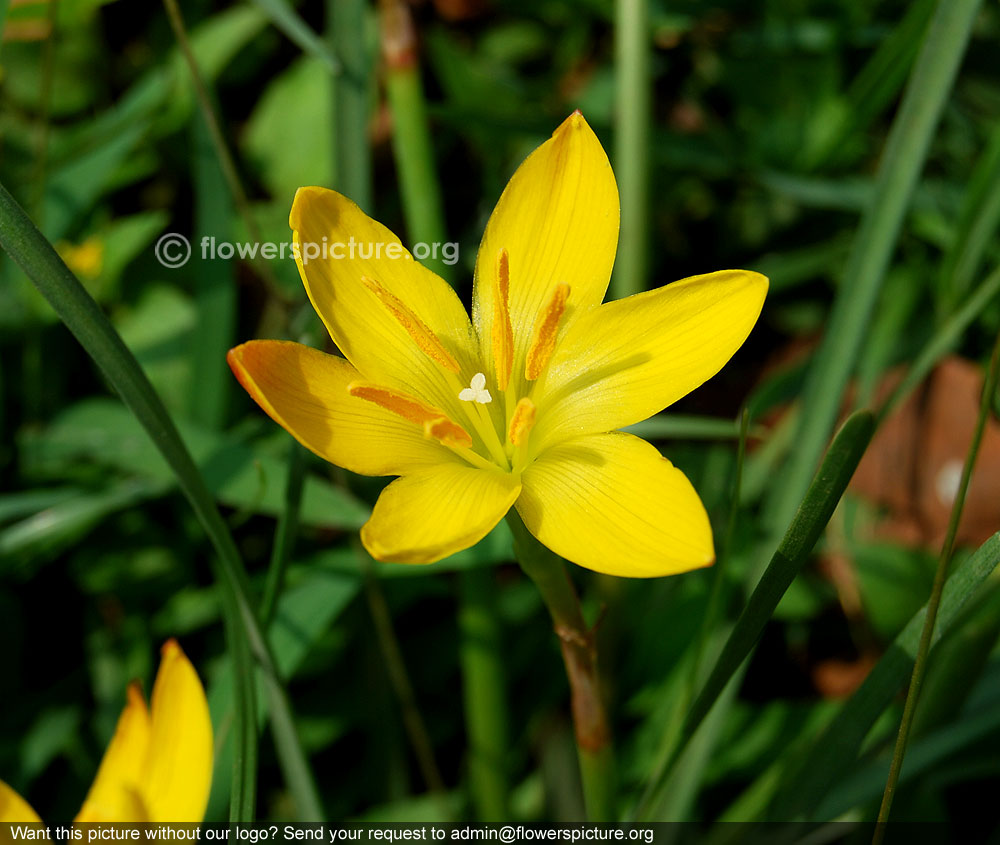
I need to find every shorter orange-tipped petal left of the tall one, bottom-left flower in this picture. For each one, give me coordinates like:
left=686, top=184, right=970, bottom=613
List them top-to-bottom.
left=76, top=683, right=149, bottom=822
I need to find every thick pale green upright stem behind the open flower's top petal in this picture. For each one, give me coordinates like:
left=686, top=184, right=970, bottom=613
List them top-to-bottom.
left=611, top=0, right=651, bottom=299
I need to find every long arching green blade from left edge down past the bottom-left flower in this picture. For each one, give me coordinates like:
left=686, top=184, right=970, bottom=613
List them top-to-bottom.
left=0, top=185, right=322, bottom=821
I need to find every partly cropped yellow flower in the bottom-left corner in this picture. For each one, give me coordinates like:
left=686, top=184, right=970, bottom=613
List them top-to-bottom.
left=0, top=640, right=212, bottom=823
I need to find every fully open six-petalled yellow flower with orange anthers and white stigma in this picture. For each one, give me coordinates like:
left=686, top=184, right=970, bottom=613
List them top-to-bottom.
left=228, top=112, right=767, bottom=576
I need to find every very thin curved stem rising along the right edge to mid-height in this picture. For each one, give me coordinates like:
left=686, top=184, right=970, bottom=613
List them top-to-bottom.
left=872, top=328, right=1000, bottom=832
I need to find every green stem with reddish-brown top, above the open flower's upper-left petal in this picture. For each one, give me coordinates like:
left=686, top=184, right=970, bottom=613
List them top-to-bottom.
left=379, top=0, right=451, bottom=278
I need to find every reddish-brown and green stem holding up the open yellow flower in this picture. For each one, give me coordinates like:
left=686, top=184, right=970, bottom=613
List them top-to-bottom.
left=507, top=510, right=616, bottom=822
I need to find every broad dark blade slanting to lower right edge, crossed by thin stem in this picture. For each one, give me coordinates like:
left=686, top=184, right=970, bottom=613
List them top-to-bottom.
left=768, top=533, right=1000, bottom=821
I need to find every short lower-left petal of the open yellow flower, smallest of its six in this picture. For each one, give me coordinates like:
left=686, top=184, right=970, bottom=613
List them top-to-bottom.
left=361, top=464, right=521, bottom=563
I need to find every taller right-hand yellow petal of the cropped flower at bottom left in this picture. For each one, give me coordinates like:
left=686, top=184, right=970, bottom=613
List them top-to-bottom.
left=141, top=640, right=212, bottom=822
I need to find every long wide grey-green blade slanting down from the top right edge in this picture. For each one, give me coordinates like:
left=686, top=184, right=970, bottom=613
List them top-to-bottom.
left=764, top=0, right=980, bottom=568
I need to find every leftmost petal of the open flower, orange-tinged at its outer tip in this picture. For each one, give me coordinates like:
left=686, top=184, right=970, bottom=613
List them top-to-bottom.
left=227, top=340, right=453, bottom=475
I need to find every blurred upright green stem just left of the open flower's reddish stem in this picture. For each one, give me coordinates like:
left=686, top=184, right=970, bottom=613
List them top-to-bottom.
left=458, top=568, right=509, bottom=822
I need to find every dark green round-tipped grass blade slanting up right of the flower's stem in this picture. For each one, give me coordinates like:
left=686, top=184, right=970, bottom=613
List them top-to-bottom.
left=635, top=411, right=875, bottom=821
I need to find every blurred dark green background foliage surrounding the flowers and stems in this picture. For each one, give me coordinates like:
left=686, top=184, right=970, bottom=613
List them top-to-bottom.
left=0, top=0, right=1000, bottom=822
